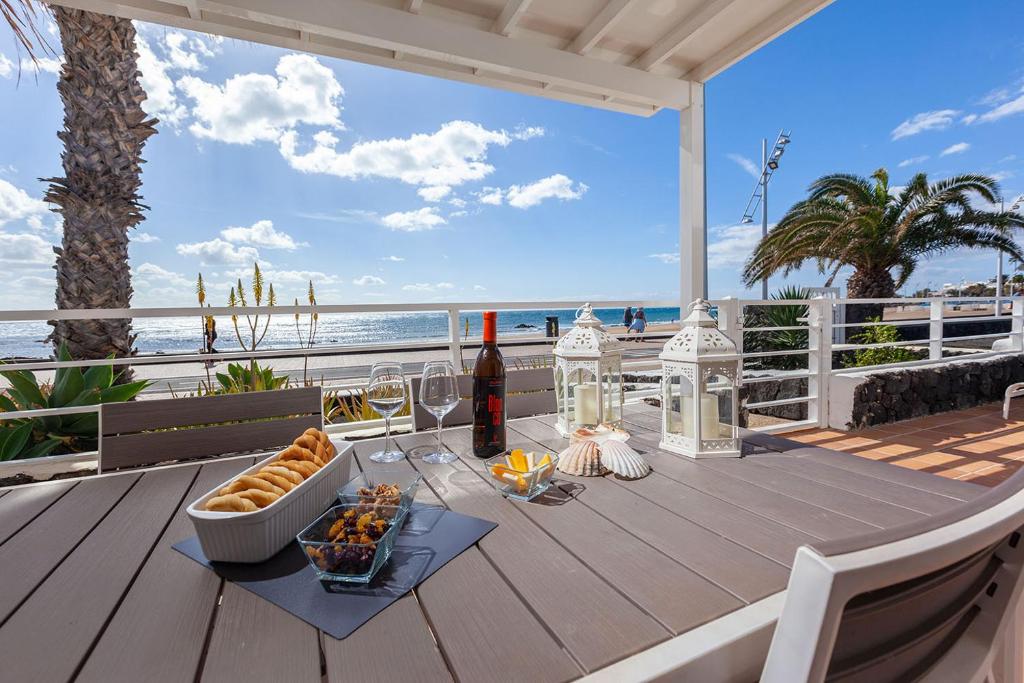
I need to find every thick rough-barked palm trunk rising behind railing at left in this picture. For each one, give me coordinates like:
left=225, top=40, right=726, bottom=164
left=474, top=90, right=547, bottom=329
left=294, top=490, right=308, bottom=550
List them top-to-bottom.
left=45, top=6, right=157, bottom=374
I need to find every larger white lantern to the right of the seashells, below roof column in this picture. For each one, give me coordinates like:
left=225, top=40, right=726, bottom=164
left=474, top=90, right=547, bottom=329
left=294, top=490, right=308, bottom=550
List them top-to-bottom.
left=658, top=299, right=742, bottom=458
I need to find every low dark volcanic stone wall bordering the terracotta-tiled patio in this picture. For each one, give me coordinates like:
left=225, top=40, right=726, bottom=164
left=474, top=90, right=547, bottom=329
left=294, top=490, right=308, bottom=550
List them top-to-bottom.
left=829, top=354, right=1024, bottom=429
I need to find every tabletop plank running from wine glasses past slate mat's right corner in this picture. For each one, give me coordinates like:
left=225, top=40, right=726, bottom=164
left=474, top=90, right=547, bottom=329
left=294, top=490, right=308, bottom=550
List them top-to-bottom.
left=389, top=430, right=671, bottom=671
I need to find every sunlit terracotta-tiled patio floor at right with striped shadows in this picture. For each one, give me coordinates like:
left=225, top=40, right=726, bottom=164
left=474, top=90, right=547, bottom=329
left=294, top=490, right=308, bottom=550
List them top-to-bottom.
left=786, top=399, right=1024, bottom=486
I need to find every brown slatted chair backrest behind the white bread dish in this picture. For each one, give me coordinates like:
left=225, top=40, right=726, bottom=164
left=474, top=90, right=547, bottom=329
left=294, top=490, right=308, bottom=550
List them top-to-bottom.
left=99, top=387, right=324, bottom=471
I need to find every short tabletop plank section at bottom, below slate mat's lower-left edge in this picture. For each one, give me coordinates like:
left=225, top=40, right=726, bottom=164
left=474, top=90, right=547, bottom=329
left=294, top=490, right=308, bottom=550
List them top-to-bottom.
left=201, top=582, right=319, bottom=683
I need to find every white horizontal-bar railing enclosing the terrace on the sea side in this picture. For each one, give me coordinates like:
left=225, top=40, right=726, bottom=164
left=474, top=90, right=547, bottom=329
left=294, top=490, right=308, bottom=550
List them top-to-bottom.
left=0, top=297, right=1024, bottom=446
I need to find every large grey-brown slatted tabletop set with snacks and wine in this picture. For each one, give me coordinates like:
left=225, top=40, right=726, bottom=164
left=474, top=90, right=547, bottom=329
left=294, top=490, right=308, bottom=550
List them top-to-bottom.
left=0, top=405, right=985, bottom=683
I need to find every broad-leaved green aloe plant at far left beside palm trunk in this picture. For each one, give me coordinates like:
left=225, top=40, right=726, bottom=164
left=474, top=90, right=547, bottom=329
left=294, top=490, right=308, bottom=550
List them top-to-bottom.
left=0, top=344, right=150, bottom=461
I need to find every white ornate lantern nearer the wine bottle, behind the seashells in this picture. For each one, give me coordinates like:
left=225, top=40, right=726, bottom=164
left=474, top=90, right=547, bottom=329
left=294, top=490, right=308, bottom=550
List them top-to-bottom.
left=555, top=303, right=623, bottom=435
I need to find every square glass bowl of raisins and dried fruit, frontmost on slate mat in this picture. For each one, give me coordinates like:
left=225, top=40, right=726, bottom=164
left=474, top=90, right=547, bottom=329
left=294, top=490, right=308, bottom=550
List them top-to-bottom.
left=296, top=503, right=408, bottom=584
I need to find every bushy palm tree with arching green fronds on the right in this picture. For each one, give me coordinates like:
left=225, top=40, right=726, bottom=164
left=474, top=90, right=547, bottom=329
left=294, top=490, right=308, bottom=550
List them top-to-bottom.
left=743, top=168, right=1024, bottom=323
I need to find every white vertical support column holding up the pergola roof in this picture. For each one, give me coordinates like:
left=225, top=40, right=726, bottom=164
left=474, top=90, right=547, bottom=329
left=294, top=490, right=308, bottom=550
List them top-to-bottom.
left=679, top=83, right=708, bottom=319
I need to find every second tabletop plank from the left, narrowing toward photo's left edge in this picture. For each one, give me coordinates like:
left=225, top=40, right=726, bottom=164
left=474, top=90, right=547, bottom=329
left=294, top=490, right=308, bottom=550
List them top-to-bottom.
left=0, top=475, right=138, bottom=624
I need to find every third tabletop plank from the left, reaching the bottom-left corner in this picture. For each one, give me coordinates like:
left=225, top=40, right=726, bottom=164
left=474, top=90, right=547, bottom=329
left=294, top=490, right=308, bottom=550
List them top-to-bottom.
left=0, top=468, right=195, bottom=681
